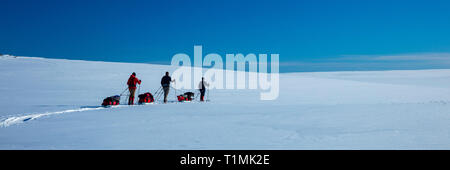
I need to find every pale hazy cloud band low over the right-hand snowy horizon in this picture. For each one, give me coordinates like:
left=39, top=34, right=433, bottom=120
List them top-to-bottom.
left=280, top=53, right=450, bottom=72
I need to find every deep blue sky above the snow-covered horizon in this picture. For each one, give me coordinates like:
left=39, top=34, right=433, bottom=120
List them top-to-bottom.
left=0, top=0, right=450, bottom=71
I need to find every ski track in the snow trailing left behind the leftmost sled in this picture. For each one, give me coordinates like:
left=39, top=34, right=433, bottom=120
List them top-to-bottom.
left=0, top=107, right=105, bottom=127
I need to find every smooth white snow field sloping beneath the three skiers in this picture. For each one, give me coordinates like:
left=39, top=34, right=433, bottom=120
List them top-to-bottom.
left=0, top=56, right=450, bottom=149
